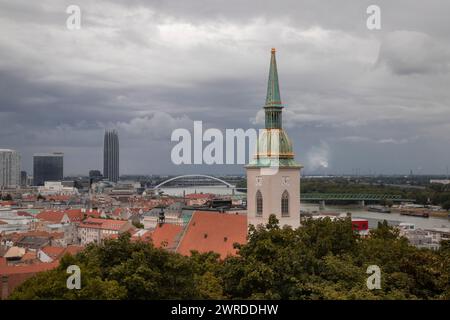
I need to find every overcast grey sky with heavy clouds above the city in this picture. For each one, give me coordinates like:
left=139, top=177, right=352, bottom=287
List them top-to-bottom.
left=0, top=0, right=450, bottom=174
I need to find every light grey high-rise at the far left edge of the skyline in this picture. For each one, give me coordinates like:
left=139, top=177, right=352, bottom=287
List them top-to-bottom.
left=0, top=149, right=20, bottom=187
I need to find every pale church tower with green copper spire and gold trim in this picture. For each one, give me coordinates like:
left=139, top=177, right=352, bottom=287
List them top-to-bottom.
left=246, top=48, right=303, bottom=228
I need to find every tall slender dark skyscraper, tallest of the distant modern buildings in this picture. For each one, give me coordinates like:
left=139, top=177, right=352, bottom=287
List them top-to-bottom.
left=103, top=130, right=119, bottom=182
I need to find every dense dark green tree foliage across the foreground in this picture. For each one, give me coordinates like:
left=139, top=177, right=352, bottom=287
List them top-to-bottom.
left=11, top=216, right=450, bottom=299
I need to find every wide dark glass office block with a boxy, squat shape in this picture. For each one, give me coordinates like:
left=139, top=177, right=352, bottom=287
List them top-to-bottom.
left=33, top=152, right=64, bottom=186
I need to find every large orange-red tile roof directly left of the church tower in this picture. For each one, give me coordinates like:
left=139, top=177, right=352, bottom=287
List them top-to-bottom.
left=177, top=211, right=247, bottom=258
